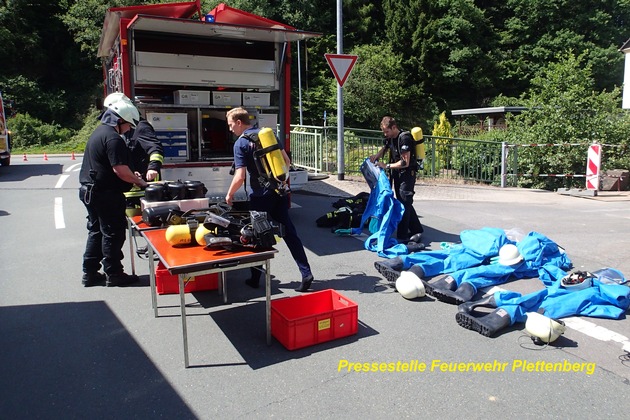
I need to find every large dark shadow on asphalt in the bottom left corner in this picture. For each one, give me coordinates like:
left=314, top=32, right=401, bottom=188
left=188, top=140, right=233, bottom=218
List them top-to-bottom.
left=0, top=302, right=195, bottom=419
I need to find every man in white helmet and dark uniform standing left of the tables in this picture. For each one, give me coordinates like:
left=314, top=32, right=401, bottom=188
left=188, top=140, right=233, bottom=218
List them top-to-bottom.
left=79, top=93, right=147, bottom=287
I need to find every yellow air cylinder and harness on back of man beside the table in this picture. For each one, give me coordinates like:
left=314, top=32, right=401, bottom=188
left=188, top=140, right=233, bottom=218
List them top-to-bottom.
left=242, top=128, right=290, bottom=196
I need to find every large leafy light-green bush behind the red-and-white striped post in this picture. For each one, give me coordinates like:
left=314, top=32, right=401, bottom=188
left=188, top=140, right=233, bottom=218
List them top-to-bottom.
left=504, top=53, right=630, bottom=190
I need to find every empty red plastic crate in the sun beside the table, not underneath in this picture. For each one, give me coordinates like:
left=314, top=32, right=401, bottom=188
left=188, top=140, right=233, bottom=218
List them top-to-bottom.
left=271, top=289, right=359, bottom=350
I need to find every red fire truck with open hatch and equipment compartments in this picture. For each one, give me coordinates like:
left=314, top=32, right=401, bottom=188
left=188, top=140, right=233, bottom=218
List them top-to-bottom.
left=98, top=0, right=319, bottom=194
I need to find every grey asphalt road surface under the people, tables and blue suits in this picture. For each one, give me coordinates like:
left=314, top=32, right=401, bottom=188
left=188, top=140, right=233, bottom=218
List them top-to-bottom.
left=0, top=156, right=630, bottom=419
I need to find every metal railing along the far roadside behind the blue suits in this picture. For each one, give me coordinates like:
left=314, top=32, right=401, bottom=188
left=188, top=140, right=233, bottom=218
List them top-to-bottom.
left=291, top=126, right=619, bottom=187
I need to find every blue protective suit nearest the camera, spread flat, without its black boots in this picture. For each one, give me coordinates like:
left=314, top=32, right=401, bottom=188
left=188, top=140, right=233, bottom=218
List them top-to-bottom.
left=494, top=276, right=630, bottom=324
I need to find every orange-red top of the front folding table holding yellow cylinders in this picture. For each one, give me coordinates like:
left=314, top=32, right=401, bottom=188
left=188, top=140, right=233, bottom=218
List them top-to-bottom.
left=140, top=228, right=278, bottom=274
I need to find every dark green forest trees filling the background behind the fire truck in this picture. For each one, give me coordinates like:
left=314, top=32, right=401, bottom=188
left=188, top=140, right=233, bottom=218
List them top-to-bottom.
left=0, top=0, right=630, bottom=171
